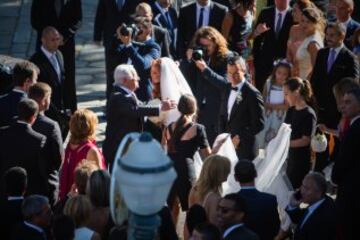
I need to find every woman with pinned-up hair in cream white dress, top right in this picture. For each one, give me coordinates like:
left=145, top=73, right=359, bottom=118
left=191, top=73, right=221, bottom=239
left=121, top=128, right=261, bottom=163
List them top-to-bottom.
left=295, top=8, right=325, bottom=79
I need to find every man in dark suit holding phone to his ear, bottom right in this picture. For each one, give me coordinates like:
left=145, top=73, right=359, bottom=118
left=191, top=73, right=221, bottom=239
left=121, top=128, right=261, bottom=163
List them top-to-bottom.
left=286, top=172, right=336, bottom=240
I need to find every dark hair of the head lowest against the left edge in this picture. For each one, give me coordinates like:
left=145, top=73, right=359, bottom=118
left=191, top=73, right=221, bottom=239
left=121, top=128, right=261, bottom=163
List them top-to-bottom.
left=4, top=167, right=27, bottom=196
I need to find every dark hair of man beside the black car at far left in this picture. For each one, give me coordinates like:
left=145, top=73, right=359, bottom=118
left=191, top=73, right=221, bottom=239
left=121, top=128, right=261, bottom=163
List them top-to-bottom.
left=13, top=61, right=39, bottom=86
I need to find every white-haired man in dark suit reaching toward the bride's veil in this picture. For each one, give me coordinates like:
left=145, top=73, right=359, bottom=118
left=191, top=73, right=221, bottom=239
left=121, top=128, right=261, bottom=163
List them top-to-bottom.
left=103, top=64, right=175, bottom=169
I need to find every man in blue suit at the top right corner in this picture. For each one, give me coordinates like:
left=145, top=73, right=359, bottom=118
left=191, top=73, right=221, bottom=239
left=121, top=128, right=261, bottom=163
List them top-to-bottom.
left=336, top=0, right=360, bottom=50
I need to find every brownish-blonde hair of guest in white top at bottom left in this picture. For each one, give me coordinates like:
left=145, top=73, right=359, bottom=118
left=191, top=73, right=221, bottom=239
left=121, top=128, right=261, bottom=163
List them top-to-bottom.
left=63, top=195, right=91, bottom=228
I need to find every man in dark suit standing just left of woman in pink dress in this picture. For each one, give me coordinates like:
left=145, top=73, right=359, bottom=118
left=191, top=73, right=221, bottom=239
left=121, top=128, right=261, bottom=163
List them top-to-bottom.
left=29, top=82, right=64, bottom=205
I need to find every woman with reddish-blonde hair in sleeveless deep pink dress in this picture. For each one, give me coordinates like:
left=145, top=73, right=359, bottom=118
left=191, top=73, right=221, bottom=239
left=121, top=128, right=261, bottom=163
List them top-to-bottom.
left=59, top=109, right=106, bottom=200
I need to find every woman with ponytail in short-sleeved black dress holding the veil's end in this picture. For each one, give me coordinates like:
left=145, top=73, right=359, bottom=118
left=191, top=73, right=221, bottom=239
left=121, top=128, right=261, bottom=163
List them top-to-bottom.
left=284, top=77, right=316, bottom=189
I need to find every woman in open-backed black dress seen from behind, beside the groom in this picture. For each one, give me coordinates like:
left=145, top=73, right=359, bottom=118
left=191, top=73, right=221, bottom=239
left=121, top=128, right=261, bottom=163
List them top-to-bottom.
left=165, top=95, right=211, bottom=220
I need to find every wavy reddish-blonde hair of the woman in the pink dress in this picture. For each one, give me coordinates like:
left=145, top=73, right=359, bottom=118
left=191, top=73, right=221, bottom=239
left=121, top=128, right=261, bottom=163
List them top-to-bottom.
left=70, top=109, right=99, bottom=144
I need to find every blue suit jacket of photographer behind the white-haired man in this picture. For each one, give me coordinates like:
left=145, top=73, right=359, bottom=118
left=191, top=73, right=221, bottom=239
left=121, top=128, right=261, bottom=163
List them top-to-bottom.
left=117, top=39, right=160, bottom=101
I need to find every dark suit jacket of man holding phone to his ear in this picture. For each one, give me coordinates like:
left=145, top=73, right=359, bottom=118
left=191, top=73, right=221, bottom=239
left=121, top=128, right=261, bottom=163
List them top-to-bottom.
left=286, top=196, right=336, bottom=240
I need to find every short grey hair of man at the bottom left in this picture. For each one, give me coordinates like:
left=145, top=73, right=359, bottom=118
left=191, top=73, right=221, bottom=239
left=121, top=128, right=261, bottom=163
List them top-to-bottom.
left=21, top=194, right=49, bottom=220
